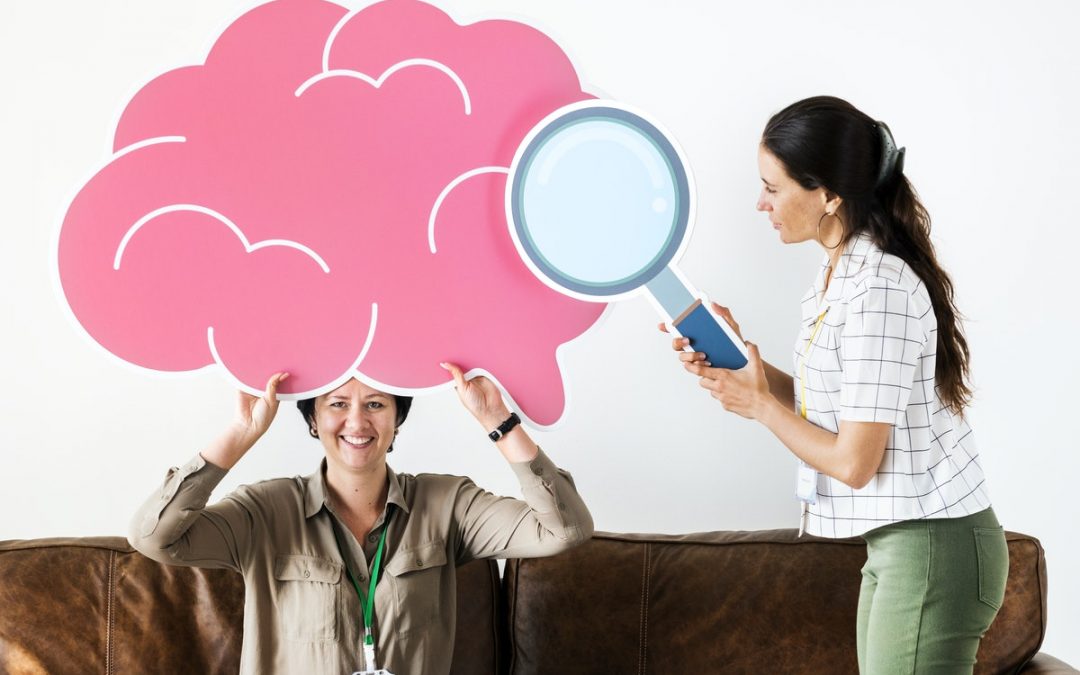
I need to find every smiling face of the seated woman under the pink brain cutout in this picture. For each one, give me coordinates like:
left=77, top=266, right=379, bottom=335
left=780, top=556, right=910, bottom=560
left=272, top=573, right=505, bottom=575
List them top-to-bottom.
left=315, top=379, right=397, bottom=470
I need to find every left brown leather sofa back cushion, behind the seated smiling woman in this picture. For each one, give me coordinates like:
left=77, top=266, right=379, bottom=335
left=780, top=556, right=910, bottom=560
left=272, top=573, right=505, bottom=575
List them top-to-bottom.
left=0, top=537, right=505, bottom=675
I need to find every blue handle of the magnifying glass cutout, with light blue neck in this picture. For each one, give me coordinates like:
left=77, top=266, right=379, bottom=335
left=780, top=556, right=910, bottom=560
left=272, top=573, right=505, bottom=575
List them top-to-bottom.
left=646, top=267, right=746, bottom=370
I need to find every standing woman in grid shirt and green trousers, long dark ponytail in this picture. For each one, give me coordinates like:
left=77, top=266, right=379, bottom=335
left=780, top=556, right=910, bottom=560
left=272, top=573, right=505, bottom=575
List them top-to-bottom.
left=674, top=96, right=1009, bottom=674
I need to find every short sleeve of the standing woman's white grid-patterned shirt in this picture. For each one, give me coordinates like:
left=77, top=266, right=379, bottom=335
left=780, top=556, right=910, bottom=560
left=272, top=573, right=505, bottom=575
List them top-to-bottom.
left=840, top=276, right=932, bottom=424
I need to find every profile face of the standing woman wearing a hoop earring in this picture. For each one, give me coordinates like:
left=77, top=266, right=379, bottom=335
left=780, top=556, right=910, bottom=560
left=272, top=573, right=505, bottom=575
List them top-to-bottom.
left=757, top=145, right=839, bottom=244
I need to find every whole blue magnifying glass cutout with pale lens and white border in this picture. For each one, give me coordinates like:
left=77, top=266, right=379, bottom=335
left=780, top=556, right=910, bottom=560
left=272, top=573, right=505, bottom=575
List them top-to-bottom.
left=507, top=100, right=746, bottom=369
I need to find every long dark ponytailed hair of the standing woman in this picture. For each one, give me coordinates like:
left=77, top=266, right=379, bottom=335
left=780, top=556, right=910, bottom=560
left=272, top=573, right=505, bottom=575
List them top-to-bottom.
left=761, top=96, right=972, bottom=414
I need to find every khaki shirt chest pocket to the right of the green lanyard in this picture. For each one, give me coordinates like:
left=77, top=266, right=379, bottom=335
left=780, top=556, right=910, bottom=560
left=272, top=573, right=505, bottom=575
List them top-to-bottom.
left=387, top=542, right=447, bottom=637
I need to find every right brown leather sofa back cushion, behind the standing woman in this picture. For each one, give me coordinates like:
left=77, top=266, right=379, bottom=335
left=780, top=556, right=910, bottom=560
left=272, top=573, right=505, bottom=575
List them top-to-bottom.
left=504, top=530, right=1047, bottom=675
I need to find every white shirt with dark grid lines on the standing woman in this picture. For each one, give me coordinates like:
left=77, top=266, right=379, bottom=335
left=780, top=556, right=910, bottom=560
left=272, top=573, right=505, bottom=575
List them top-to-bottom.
left=795, top=234, right=990, bottom=537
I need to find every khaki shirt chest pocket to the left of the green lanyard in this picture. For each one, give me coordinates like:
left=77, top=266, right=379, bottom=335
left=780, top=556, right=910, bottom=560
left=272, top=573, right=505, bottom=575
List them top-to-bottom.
left=273, top=555, right=341, bottom=642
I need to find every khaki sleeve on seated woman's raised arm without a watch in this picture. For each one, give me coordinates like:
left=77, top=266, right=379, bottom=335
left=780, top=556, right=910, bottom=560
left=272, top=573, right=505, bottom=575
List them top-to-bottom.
left=127, top=455, right=252, bottom=571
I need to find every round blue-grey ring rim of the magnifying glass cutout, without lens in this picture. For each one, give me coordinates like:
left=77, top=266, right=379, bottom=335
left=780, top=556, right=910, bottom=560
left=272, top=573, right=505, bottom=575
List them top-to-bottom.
left=508, top=100, right=693, bottom=300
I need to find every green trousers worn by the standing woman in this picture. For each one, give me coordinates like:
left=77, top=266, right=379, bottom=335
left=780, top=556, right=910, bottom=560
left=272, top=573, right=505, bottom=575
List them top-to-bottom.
left=855, top=509, right=1009, bottom=675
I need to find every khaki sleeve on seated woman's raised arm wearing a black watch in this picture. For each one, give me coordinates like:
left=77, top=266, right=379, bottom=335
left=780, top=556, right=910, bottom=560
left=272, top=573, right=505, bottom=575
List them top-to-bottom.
left=455, top=450, right=593, bottom=562
